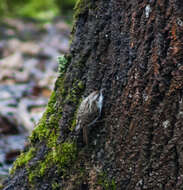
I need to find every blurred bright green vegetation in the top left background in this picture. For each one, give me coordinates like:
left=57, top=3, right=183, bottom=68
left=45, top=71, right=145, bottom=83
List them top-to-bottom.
left=0, top=0, right=76, bottom=20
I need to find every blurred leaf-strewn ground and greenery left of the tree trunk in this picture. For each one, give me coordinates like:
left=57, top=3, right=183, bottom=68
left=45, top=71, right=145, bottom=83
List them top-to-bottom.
left=0, top=0, right=76, bottom=186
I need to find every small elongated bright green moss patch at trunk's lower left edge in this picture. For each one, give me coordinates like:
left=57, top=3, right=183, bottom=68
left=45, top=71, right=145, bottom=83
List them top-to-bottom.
left=10, top=147, right=36, bottom=174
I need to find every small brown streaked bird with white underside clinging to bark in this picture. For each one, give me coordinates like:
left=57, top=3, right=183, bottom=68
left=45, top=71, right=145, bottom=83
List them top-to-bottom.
left=75, top=89, right=104, bottom=145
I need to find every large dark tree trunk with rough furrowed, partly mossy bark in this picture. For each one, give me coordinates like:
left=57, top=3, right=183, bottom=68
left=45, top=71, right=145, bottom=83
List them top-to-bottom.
left=4, top=0, right=183, bottom=190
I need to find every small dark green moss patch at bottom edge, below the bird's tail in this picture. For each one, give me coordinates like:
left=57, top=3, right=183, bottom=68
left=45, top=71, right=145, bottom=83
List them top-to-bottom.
left=98, top=173, right=117, bottom=190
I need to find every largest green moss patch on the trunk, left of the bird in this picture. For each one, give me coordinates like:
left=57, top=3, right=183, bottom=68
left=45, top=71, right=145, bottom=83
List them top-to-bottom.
left=28, top=78, right=84, bottom=183
